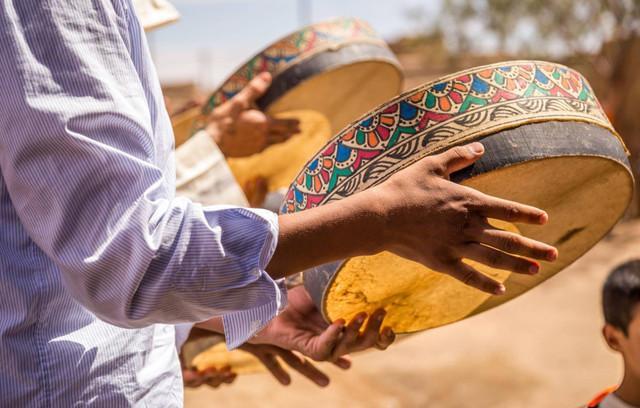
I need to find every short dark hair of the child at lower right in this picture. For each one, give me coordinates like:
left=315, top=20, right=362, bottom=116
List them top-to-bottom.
left=602, top=259, right=640, bottom=336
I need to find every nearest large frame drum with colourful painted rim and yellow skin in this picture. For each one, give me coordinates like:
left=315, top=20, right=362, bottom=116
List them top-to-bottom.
left=282, top=61, right=633, bottom=333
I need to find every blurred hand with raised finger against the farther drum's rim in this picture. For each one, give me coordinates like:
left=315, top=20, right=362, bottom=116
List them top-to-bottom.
left=206, top=72, right=300, bottom=157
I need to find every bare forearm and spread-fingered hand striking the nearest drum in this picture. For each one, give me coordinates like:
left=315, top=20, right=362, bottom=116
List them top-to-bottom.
left=267, top=143, right=558, bottom=295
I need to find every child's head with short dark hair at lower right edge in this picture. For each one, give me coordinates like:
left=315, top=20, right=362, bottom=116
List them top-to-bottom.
left=602, top=260, right=640, bottom=374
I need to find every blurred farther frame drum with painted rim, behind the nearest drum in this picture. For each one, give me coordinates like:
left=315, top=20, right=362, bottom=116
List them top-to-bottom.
left=172, top=18, right=402, bottom=196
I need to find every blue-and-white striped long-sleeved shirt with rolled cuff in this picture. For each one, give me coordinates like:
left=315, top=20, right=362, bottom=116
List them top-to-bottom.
left=0, top=0, right=286, bottom=407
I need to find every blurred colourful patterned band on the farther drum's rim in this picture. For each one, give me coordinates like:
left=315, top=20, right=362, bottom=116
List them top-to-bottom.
left=192, top=18, right=386, bottom=134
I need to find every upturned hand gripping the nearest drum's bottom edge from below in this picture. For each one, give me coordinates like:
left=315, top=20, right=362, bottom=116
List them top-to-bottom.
left=249, top=286, right=395, bottom=369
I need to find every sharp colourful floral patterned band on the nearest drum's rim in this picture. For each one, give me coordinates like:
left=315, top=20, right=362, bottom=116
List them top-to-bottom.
left=282, top=61, right=615, bottom=213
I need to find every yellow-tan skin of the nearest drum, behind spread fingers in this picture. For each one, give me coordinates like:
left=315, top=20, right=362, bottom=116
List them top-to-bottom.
left=322, top=151, right=632, bottom=333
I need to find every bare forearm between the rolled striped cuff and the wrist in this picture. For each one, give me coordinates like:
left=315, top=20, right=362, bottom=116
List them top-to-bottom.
left=267, top=189, right=387, bottom=279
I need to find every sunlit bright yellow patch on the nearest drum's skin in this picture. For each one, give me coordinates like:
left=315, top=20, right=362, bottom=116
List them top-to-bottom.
left=325, top=220, right=519, bottom=333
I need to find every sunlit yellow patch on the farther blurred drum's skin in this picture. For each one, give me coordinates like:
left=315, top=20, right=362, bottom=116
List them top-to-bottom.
left=227, top=110, right=332, bottom=191
